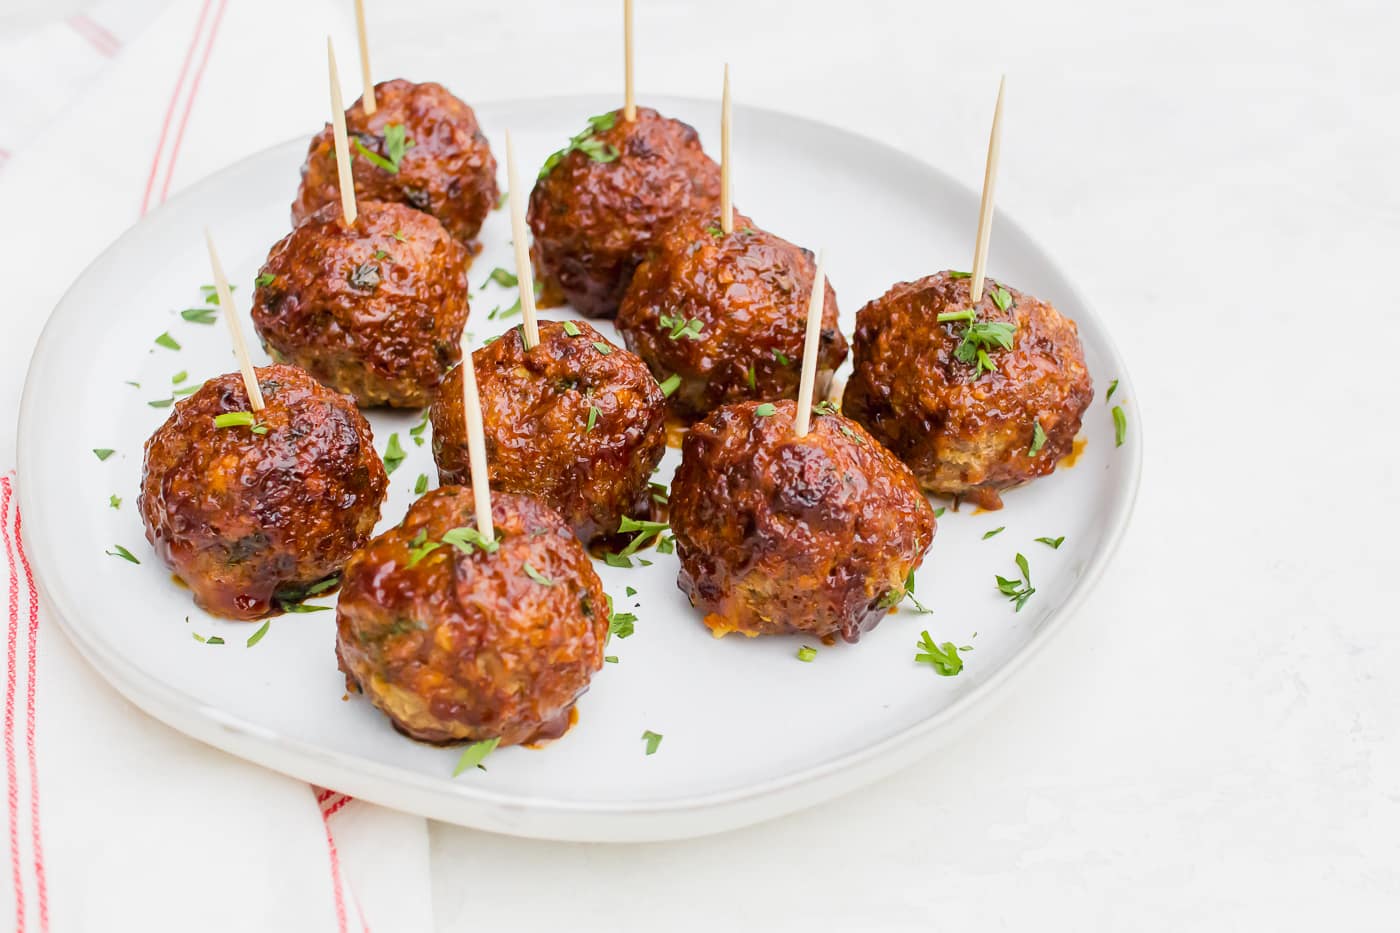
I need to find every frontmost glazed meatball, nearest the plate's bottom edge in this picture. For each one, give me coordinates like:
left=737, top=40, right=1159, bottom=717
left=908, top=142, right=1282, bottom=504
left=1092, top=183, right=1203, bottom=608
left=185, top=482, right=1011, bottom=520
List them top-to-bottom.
left=336, top=486, right=608, bottom=745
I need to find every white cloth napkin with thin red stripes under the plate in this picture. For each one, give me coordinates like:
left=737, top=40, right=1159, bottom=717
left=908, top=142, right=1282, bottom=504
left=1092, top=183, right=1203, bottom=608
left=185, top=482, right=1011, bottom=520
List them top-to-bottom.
left=0, top=0, right=433, bottom=933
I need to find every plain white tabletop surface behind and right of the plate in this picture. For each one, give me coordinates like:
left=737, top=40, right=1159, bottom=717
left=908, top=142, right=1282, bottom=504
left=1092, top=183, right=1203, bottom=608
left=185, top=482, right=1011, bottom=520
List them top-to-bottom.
left=0, top=0, right=1400, bottom=933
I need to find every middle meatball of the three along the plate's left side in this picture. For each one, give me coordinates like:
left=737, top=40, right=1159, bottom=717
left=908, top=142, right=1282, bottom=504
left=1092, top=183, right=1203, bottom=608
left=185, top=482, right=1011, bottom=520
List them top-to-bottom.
left=252, top=200, right=469, bottom=408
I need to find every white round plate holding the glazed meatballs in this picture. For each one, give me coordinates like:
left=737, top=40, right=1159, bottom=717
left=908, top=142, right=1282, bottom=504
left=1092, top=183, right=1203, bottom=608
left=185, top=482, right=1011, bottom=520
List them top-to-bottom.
left=18, top=92, right=1141, bottom=841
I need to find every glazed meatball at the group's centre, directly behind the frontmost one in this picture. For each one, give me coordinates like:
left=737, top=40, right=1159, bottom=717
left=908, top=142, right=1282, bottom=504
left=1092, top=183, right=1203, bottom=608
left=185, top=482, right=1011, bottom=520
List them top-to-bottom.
left=431, top=321, right=666, bottom=544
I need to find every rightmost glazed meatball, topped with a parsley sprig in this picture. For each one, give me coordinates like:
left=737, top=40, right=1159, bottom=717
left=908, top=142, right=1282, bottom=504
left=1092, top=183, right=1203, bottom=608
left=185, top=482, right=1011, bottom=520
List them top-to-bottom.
left=843, top=272, right=1093, bottom=509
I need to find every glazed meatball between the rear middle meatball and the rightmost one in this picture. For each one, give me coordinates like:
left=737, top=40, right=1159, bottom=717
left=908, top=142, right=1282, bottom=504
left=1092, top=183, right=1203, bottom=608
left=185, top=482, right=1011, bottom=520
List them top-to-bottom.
left=617, top=212, right=846, bottom=420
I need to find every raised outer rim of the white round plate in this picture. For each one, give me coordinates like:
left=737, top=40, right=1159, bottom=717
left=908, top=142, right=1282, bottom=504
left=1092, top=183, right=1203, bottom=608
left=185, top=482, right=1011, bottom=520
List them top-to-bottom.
left=15, top=94, right=1144, bottom=842
